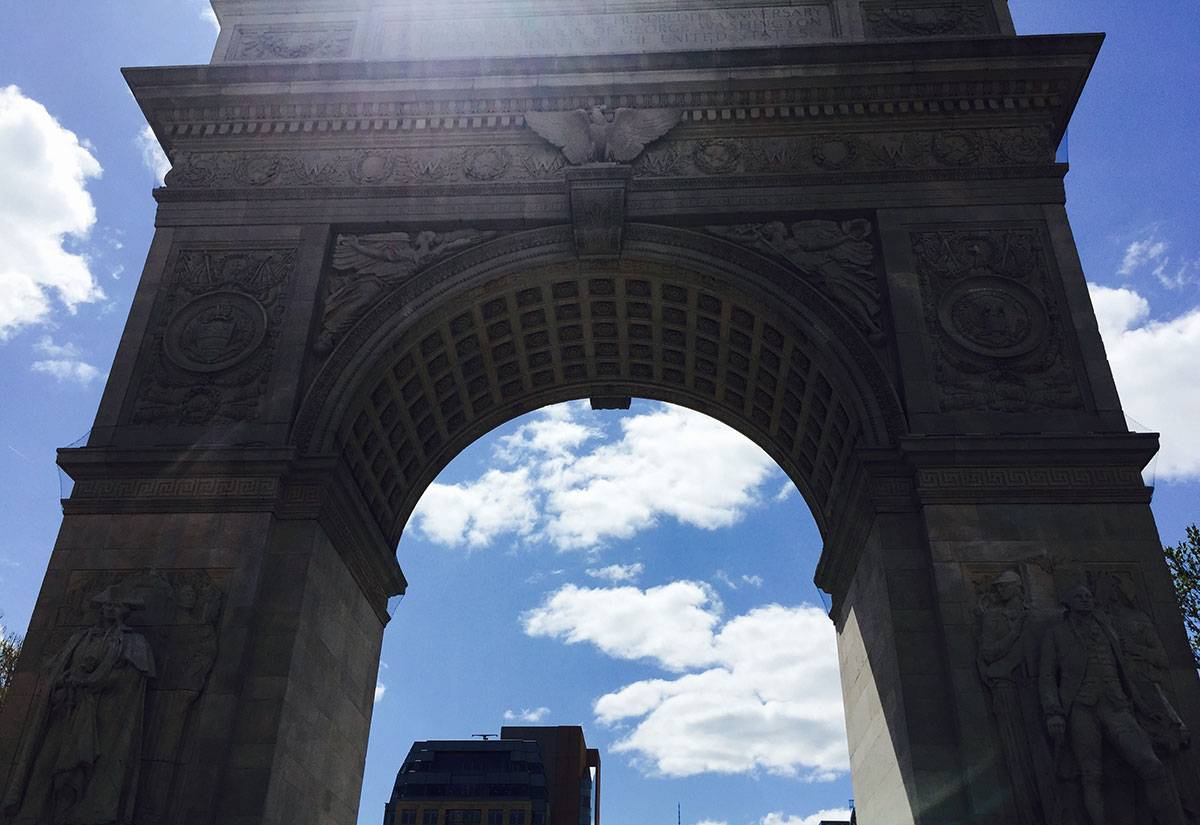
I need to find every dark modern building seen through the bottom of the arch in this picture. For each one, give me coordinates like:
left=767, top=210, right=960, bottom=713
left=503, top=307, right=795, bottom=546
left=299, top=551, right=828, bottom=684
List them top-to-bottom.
left=384, top=725, right=600, bottom=825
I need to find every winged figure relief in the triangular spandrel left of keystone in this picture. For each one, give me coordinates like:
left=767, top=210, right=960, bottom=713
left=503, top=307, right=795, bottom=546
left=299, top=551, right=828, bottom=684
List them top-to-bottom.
left=314, top=229, right=498, bottom=354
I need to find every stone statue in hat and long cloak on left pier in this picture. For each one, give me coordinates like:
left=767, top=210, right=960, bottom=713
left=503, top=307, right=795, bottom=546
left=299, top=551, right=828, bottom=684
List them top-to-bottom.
left=4, top=589, right=155, bottom=825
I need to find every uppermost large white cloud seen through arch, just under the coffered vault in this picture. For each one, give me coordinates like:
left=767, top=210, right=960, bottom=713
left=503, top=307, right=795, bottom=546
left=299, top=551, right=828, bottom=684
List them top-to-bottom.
left=414, top=403, right=778, bottom=550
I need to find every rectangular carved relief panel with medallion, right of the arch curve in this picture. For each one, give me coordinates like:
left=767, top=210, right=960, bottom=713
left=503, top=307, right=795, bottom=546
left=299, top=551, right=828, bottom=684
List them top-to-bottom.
left=910, top=225, right=1084, bottom=413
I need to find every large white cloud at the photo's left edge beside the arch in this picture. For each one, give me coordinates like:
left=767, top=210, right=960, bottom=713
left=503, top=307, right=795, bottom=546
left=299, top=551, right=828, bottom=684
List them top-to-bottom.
left=0, top=86, right=104, bottom=341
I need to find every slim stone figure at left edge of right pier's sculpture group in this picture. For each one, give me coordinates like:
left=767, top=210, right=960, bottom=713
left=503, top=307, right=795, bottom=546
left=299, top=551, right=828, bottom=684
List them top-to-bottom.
left=978, top=570, right=1044, bottom=825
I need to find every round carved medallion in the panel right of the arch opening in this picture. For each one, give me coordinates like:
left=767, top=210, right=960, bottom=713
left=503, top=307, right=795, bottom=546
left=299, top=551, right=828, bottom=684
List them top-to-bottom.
left=937, top=277, right=1046, bottom=359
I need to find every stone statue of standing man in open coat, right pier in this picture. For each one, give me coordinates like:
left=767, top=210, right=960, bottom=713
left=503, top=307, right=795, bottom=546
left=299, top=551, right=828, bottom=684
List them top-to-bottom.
left=1038, top=586, right=1184, bottom=825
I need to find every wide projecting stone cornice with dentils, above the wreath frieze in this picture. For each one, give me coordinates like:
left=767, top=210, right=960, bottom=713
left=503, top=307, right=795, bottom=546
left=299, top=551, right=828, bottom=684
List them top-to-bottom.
left=125, top=35, right=1102, bottom=151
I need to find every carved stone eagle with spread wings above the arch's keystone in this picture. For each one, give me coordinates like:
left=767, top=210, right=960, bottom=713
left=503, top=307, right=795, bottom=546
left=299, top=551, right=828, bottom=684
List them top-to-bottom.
left=524, top=106, right=683, bottom=165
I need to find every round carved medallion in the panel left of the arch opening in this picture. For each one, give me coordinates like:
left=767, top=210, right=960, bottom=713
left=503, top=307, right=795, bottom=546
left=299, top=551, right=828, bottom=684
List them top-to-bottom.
left=163, top=291, right=266, bottom=373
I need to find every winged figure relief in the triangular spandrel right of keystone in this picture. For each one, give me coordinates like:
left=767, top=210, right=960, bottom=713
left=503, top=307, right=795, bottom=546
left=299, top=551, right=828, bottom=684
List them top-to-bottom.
left=707, top=218, right=883, bottom=343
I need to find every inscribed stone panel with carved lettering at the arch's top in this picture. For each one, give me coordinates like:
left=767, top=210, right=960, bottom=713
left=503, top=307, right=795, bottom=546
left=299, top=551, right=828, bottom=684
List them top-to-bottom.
left=371, top=2, right=838, bottom=59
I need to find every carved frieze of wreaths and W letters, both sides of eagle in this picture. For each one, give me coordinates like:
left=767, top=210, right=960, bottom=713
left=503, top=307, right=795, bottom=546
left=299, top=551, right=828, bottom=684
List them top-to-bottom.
left=167, top=127, right=1054, bottom=189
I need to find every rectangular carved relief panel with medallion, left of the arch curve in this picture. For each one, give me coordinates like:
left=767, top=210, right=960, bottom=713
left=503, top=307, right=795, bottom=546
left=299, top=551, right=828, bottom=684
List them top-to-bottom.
left=127, top=244, right=295, bottom=426
